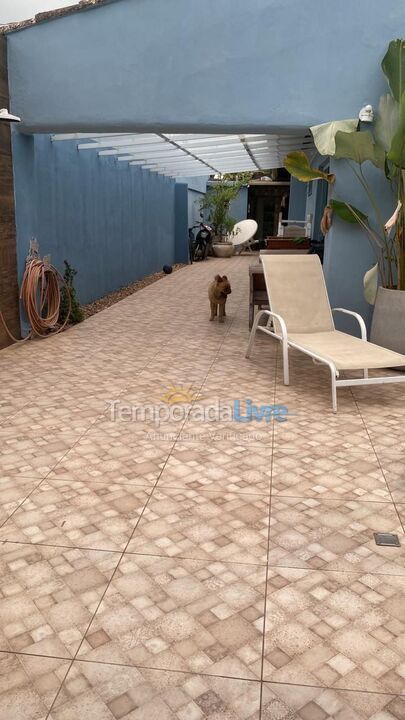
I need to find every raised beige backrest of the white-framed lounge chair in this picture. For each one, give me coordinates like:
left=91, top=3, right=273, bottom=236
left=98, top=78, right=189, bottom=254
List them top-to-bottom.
left=260, top=255, right=335, bottom=334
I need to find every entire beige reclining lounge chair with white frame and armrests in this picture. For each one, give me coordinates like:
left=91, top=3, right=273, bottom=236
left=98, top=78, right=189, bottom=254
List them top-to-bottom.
left=246, top=255, right=405, bottom=412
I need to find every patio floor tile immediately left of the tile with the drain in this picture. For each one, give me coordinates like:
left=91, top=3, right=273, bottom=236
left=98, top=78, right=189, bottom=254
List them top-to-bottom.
left=128, top=487, right=269, bottom=563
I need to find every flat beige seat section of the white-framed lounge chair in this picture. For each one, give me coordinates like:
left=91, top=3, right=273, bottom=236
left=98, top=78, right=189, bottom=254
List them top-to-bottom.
left=288, top=330, right=405, bottom=370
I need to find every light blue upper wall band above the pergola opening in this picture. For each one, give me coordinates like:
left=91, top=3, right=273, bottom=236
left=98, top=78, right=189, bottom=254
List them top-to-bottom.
left=8, top=0, right=405, bottom=132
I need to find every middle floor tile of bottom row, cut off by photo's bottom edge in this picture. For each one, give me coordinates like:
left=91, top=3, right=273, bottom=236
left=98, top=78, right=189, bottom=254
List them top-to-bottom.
left=50, top=661, right=260, bottom=720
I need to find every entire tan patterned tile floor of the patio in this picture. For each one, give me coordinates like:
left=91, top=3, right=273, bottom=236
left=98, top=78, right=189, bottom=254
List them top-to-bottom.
left=0, top=256, right=405, bottom=720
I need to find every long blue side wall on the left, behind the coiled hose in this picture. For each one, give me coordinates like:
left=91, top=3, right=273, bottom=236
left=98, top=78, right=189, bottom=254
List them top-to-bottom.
left=13, top=134, right=176, bottom=303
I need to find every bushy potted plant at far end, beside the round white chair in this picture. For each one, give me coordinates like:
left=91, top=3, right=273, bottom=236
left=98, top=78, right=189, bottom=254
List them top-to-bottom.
left=201, top=173, right=248, bottom=257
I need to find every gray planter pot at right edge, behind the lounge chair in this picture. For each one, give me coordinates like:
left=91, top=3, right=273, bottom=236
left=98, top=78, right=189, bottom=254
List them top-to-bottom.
left=370, top=287, right=405, bottom=372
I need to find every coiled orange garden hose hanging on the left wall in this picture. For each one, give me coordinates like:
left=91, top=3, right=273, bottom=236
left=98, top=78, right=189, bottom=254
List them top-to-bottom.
left=0, top=257, right=71, bottom=342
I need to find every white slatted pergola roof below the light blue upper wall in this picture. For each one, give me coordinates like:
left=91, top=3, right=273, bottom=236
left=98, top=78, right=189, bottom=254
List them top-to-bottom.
left=52, top=132, right=313, bottom=177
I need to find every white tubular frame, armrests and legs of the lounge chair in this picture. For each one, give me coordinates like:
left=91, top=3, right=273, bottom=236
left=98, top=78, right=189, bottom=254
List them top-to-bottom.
left=246, top=256, right=405, bottom=412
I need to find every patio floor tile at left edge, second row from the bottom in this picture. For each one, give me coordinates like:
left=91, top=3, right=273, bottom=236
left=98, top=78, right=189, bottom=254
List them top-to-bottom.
left=0, top=543, right=119, bottom=659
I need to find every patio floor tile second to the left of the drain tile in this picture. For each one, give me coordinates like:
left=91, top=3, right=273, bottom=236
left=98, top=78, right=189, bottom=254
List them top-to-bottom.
left=0, top=479, right=149, bottom=551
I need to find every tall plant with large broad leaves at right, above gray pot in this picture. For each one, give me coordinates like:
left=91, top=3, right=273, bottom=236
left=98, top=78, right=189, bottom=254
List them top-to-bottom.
left=284, top=40, right=405, bottom=303
